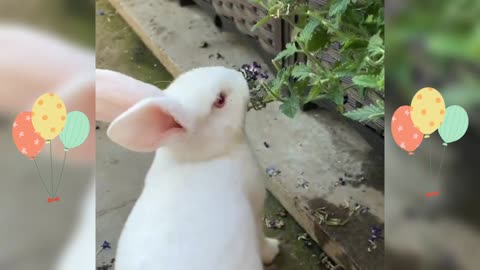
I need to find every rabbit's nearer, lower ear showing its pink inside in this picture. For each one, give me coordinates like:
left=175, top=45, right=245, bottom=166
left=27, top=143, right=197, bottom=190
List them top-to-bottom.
left=107, top=96, right=185, bottom=152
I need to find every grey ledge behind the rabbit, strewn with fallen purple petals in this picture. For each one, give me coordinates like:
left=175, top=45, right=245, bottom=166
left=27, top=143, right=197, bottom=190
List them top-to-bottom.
left=110, top=0, right=384, bottom=270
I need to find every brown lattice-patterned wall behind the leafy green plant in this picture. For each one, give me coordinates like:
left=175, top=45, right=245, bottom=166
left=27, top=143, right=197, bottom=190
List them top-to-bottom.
left=180, top=0, right=385, bottom=136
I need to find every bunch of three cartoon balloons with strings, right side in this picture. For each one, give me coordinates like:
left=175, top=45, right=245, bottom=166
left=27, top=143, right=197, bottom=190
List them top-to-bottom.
left=390, top=87, right=469, bottom=198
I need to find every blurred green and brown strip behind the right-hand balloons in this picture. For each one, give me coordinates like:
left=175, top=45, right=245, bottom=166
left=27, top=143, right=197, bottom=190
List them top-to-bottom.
left=385, top=0, right=480, bottom=270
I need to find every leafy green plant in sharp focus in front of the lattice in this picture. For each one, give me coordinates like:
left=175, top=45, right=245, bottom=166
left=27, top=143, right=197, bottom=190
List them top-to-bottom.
left=252, top=0, right=385, bottom=122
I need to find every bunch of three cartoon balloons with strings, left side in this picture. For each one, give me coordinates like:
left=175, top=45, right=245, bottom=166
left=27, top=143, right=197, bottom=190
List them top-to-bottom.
left=12, top=93, right=90, bottom=203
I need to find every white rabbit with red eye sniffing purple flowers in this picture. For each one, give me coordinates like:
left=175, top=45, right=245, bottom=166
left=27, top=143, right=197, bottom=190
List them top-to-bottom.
left=107, top=67, right=279, bottom=270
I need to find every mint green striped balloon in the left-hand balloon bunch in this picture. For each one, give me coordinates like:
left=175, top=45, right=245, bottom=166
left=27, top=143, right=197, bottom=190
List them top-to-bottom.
left=59, top=111, right=90, bottom=151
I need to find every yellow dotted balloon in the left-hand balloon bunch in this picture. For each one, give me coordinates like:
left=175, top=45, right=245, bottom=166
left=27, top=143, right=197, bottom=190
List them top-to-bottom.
left=32, top=93, right=67, bottom=143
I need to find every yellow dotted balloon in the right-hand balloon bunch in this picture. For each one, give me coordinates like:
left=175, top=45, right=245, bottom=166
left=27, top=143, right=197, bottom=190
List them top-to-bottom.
left=410, top=87, right=445, bottom=138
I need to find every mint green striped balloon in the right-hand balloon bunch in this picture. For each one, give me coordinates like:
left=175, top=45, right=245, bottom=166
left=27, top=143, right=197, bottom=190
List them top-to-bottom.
left=438, top=105, right=468, bottom=146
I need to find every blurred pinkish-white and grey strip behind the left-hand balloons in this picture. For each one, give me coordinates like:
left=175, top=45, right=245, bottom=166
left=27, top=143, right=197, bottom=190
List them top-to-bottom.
left=0, top=0, right=95, bottom=270
